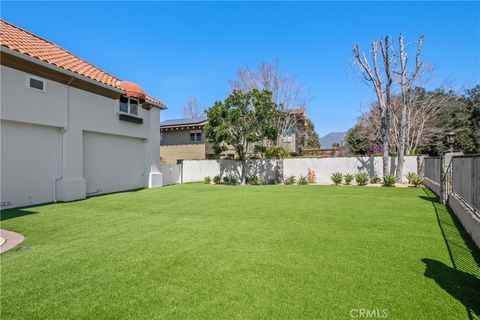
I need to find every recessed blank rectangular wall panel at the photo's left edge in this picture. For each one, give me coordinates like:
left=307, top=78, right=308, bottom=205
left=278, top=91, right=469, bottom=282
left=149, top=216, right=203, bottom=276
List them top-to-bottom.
left=1, top=120, right=59, bottom=208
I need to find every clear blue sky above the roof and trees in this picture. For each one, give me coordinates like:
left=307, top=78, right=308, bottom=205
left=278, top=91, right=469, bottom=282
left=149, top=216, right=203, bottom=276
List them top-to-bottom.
left=1, top=1, right=480, bottom=135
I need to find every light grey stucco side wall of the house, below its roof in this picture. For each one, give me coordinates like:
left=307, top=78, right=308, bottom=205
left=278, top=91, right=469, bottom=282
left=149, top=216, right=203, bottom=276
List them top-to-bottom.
left=0, top=65, right=162, bottom=209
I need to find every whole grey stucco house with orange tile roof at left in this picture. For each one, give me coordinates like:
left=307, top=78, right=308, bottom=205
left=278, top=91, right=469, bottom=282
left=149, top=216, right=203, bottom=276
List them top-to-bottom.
left=0, top=20, right=165, bottom=209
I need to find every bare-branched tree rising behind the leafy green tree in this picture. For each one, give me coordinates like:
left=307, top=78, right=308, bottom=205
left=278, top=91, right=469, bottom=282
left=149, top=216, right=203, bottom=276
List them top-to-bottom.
left=230, top=62, right=310, bottom=145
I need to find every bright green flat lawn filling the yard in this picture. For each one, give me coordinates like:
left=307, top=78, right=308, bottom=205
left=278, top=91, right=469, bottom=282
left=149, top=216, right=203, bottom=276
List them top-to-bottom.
left=1, top=184, right=480, bottom=319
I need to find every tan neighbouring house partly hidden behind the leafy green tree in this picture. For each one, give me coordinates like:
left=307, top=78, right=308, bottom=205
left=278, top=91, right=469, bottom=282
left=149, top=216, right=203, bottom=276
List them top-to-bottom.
left=160, top=109, right=305, bottom=164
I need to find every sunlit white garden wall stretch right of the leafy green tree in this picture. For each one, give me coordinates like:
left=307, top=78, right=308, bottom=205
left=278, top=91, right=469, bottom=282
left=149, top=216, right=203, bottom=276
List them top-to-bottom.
left=283, top=156, right=417, bottom=184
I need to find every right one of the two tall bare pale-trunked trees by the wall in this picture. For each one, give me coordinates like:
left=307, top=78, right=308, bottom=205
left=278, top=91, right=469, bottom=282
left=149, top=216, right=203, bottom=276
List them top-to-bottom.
left=396, top=34, right=423, bottom=180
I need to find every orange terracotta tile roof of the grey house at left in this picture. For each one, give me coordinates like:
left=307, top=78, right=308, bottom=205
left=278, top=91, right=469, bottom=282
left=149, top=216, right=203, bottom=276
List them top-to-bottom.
left=0, top=19, right=165, bottom=106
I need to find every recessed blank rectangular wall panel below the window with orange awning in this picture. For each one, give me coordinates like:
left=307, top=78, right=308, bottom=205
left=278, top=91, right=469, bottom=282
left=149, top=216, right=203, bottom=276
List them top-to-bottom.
left=83, top=132, right=144, bottom=195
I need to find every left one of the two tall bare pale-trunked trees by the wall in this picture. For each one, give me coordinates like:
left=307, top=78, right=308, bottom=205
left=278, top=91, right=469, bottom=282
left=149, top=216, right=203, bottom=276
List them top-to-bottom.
left=353, top=36, right=395, bottom=176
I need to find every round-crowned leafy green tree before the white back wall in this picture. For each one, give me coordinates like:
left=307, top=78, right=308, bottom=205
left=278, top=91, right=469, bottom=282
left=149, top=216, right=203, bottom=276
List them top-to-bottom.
left=205, top=89, right=279, bottom=184
